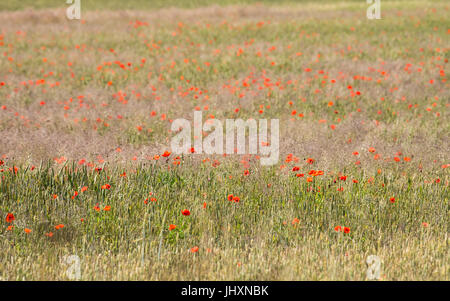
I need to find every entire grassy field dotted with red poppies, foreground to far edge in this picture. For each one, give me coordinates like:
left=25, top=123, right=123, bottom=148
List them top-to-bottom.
left=0, top=0, right=450, bottom=280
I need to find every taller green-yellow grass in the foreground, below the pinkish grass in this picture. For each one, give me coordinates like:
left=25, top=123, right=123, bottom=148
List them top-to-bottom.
left=0, top=160, right=448, bottom=280
